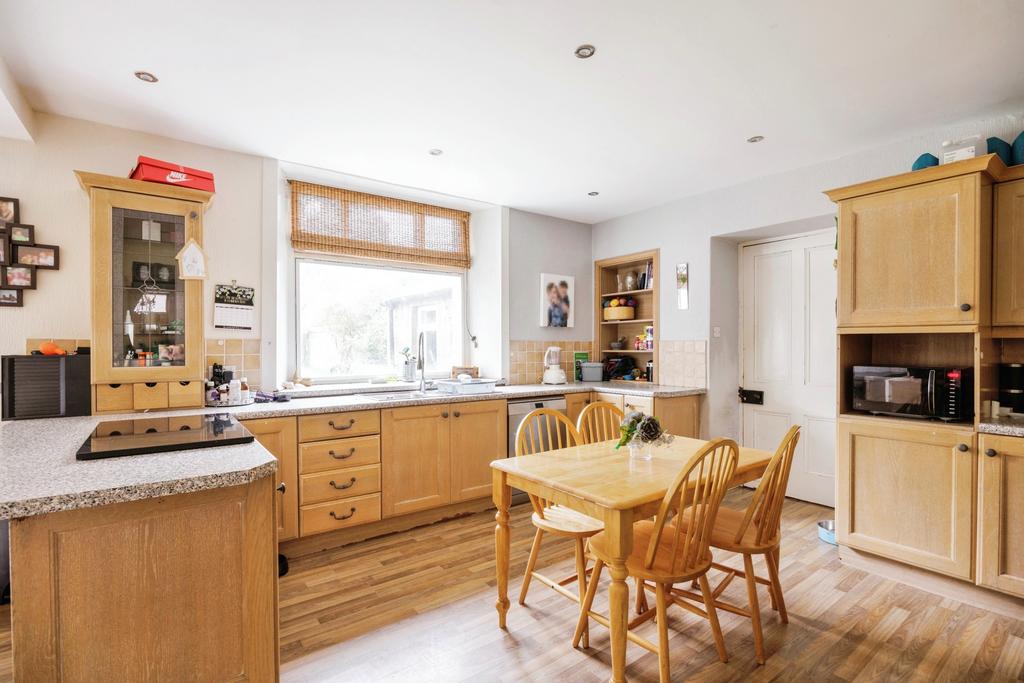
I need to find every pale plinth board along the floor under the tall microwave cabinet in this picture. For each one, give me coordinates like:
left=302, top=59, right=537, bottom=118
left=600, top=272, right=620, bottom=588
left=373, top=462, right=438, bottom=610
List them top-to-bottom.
left=839, top=546, right=1024, bottom=620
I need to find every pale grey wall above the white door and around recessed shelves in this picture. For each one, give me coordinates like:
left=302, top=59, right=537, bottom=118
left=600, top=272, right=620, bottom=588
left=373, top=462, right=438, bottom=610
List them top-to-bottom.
left=593, top=112, right=1024, bottom=434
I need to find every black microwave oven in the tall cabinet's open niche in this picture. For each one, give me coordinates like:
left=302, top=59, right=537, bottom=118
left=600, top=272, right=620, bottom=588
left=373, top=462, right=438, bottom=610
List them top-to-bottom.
left=851, top=366, right=974, bottom=422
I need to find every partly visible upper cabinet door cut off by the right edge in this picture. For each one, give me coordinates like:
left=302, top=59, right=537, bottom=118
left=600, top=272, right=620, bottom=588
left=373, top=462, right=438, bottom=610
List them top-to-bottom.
left=992, top=180, right=1024, bottom=325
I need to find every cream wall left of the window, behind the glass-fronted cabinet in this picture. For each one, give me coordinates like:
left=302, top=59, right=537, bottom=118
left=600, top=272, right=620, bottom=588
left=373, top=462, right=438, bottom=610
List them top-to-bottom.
left=0, top=114, right=261, bottom=354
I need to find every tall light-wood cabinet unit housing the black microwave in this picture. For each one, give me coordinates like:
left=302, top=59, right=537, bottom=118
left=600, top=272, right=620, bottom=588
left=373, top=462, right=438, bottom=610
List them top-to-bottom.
left=826, top=155, right=1024, bottom=596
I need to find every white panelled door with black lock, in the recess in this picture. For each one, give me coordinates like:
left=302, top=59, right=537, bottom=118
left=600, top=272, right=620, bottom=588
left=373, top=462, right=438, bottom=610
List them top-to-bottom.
left=739, top=230, right=836, bottom=507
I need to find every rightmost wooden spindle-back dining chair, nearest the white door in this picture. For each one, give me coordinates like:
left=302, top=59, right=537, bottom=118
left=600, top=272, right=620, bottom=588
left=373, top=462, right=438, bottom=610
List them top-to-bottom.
left=673, top=426, right=800, bottom=664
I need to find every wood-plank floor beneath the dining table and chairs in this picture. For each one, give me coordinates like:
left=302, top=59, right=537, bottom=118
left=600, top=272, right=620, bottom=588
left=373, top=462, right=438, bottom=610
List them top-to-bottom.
left=0, top=492, right=1024, bottom=683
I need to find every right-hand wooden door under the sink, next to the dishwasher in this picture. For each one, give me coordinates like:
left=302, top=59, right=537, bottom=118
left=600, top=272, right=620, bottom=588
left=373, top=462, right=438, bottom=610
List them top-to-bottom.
left=451, top=400, right=508, bottom=503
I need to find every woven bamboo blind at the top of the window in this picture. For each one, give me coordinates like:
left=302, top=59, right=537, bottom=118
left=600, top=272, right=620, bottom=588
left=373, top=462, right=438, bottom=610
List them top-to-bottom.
left=289, top=180, right=469, bottom=269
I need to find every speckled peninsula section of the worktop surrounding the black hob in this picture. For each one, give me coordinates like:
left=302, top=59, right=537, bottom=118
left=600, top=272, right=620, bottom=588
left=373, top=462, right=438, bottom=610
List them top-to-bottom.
left=0, top=411, right=278, bottom=519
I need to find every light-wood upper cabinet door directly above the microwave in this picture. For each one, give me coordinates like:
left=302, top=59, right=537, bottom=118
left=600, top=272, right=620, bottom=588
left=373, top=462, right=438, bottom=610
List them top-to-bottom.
left=839, top=174, right=987, bottom=327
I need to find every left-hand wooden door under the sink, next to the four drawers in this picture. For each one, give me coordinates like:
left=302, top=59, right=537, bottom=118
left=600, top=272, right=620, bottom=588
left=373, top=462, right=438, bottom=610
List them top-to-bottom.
left=381, top=403, right=452, bottom=517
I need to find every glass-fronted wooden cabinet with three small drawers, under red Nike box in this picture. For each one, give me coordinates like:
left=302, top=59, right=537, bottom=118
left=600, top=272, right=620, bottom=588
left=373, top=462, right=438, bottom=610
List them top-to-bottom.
left=77, top=171, right=212, bottom=412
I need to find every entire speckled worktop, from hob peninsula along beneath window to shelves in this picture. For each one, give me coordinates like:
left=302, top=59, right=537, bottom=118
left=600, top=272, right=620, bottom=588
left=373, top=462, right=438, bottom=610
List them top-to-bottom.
left=0, top=382, right=705, bottom=519
